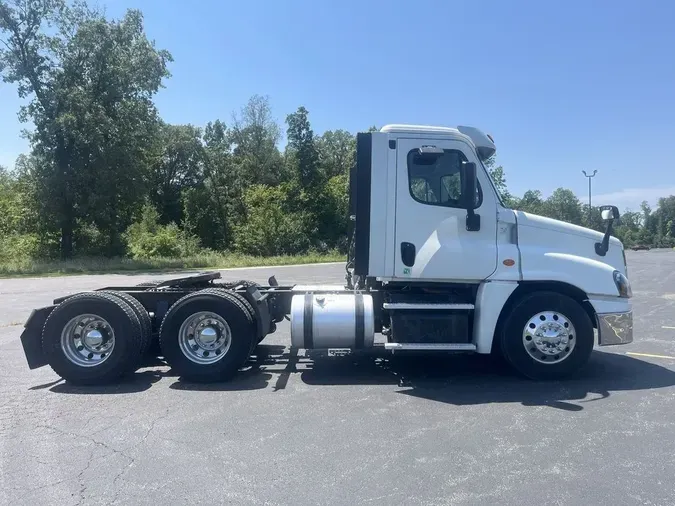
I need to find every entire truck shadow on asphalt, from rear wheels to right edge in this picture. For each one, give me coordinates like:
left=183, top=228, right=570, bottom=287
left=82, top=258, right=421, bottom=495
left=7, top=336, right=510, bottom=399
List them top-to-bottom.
left=46, top=345, right=675, bottom=411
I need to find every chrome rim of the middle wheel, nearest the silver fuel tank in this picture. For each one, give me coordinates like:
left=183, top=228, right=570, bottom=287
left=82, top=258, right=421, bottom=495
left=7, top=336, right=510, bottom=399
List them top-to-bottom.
left=178, top=311, right=232, bottom=365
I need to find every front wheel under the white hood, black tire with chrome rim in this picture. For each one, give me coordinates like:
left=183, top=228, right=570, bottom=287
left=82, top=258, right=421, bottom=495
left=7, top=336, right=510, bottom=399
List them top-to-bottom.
left=499, top=292, right=595, bottom=380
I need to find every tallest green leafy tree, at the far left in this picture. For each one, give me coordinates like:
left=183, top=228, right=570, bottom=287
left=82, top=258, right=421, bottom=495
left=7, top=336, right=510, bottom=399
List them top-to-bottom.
left=0, top=0, right=171, bottom=258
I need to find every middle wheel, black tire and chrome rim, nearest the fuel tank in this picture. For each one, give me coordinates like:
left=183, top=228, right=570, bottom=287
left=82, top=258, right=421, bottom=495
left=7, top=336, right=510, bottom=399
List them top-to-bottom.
left=159, top=288, right=255, bottom=383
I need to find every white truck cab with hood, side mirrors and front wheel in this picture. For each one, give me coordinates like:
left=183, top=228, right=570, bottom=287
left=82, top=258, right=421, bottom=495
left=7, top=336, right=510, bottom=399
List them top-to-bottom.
left=350, top=125, right=632, bottom=376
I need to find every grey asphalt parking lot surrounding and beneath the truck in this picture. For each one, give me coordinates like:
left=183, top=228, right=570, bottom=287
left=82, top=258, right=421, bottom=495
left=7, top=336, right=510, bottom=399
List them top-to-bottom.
left=0, top=250, right=675, bottom=506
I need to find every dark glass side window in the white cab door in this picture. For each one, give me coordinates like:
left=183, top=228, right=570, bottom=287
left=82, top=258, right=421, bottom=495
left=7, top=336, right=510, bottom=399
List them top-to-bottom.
left=408, top=149, right=483, bottom=208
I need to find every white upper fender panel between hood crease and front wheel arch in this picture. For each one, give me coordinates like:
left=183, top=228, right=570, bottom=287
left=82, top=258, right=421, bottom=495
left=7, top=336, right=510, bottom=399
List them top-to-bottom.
left=522, top=250, right=619, bottom=297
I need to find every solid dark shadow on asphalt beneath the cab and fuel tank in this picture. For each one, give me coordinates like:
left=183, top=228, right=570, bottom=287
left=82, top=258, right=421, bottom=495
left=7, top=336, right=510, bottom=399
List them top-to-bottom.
left=301, top=351, right=675, bottom=411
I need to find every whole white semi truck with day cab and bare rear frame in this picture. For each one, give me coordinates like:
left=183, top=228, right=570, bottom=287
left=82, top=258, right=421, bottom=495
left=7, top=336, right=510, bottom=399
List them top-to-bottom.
left=21, top=125, right=633, bottom=384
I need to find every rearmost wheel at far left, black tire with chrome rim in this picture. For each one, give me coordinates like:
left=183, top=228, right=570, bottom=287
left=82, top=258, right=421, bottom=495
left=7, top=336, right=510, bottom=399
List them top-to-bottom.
left=42, top=292, right=143, bottom=385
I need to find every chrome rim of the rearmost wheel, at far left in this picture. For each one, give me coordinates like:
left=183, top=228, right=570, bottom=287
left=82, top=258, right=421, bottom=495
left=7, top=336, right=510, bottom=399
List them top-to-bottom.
left=61, top=314, right=115, bottom=367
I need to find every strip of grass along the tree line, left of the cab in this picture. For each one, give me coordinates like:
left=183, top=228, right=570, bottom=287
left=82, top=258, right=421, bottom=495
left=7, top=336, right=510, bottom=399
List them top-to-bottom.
left=0, top=252, right=346, bottom=278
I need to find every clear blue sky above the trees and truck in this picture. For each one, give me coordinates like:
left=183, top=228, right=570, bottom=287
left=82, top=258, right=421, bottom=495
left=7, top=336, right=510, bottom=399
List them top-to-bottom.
left=0, top=0, right=675, bottom=209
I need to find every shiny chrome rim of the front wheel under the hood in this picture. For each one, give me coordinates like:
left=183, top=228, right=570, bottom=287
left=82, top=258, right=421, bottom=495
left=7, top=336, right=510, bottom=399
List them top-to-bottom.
left=523, top=311, right=577, bottom=364
